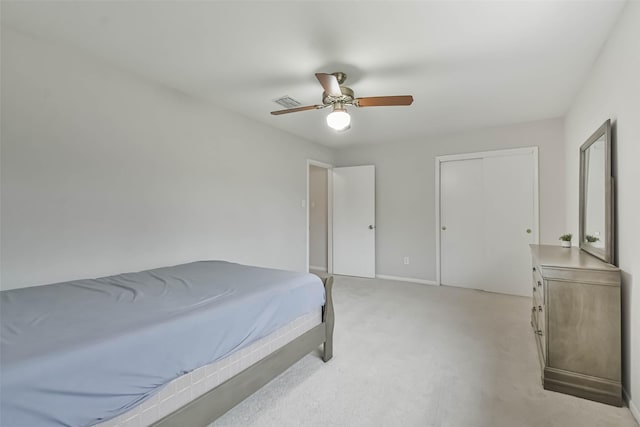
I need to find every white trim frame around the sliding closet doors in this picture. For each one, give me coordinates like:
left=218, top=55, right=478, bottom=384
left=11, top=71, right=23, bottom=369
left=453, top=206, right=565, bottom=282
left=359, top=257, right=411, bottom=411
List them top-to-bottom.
left=435, top=146, right=540, bottom=285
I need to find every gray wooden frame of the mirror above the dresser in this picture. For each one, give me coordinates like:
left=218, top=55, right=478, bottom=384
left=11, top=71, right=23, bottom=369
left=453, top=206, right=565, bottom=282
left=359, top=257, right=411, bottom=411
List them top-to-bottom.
left=578, top=119, right=614, bottom=264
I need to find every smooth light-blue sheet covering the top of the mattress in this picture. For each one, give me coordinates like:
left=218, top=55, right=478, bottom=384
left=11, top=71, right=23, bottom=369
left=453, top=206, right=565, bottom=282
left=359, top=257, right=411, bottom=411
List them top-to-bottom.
left=0, top=261, right=325, bottom=427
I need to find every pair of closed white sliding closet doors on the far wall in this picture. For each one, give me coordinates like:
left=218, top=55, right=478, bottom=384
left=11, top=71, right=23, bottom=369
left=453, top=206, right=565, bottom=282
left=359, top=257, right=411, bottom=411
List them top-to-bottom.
left=440, top=149, right=537, bottom=296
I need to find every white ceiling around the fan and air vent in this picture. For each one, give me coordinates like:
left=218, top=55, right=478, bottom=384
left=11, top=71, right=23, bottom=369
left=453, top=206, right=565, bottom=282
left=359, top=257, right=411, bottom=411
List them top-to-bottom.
left=2, top=0, right=624, bottom=147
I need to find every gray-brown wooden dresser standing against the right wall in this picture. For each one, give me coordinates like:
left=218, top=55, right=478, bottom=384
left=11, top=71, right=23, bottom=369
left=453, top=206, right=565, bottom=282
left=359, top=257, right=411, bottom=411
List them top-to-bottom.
left=531, top=245, right=622, bottom=406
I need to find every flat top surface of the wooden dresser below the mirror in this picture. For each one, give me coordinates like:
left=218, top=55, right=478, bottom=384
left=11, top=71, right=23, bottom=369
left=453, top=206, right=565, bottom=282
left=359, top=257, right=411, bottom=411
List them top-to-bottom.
left=529, top=245, right=620, bottom=271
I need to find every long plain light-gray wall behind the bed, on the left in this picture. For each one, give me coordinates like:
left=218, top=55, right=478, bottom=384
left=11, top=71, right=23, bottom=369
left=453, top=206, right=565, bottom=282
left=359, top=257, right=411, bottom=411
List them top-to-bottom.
left=0, top=27, right=331, bottom=289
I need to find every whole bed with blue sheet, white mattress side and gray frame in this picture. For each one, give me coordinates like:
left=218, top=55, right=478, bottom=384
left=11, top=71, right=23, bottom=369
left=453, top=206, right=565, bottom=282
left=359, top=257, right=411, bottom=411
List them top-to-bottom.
left=0, top=261, right=333, bottom=427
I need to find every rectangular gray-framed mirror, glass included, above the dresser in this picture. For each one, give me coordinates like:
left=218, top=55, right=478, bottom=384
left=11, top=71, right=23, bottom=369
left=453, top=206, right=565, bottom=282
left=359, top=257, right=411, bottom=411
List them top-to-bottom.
left=579, top=120, right=613, bottom=263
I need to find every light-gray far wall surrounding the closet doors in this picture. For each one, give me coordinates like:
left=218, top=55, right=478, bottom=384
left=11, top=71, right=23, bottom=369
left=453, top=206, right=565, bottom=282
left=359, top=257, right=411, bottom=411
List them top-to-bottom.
left=336, top=119, right=565, bottom=281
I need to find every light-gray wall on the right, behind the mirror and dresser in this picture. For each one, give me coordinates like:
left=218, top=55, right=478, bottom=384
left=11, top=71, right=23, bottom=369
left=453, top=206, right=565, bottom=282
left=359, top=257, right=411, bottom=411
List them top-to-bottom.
left=565, top=1, right=640, bottom=420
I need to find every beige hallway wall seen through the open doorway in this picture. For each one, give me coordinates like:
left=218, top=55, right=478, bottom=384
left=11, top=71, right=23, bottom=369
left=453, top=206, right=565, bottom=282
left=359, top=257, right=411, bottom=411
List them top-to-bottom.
left=309, top=165, right=328, bottom=270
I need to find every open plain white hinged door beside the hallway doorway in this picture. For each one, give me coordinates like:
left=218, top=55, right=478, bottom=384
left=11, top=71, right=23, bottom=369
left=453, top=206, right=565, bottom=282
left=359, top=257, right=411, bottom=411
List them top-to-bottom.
left=332, top=165, right=376, bottom=278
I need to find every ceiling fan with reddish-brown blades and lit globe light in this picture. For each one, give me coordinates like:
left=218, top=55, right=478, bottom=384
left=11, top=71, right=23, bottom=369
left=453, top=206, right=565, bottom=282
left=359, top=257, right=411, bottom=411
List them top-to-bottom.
left=271, top=72, right=413, bottom=131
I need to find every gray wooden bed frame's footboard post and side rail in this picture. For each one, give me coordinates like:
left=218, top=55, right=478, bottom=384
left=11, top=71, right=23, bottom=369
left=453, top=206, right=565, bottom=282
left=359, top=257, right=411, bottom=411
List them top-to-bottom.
left=152, top=276, right=334, bottom=427
